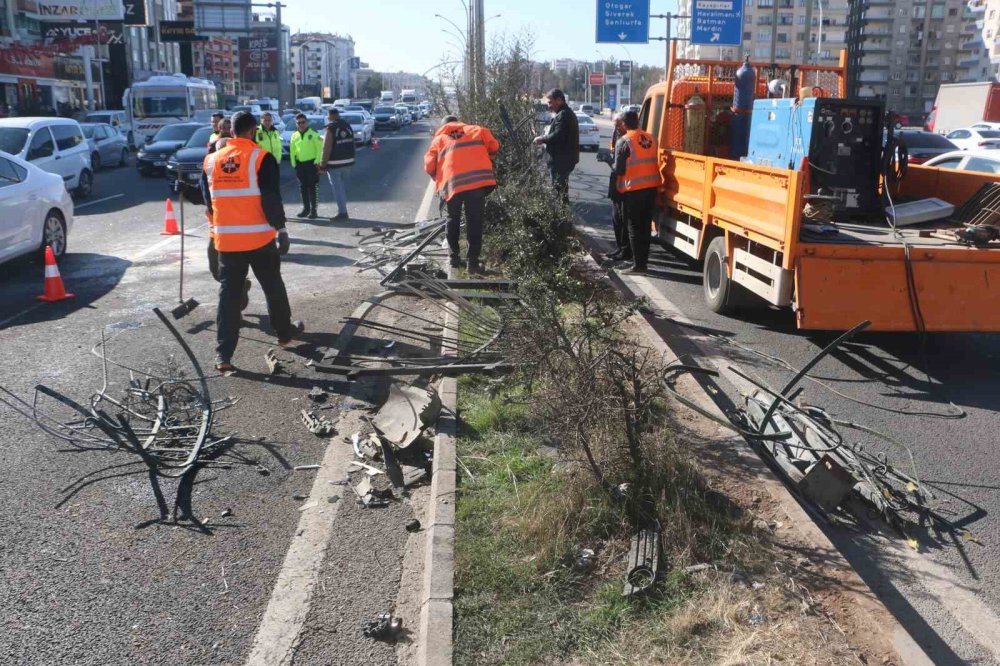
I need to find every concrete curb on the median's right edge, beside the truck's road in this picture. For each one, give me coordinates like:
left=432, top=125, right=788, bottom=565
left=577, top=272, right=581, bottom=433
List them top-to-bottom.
left=574, top=224, right=934, bottom=666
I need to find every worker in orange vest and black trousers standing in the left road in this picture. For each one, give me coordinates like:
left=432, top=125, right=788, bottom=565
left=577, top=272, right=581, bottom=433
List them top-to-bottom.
left=202, top=111, right=305, bottom=372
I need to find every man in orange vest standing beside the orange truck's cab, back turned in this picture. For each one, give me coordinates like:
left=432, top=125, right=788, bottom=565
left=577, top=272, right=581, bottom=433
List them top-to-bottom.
left=611, top=111, right=661, bottom=273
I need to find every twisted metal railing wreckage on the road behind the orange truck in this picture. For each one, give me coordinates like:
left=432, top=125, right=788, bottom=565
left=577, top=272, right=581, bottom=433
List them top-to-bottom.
left=664, top=322, right=959, bottom=545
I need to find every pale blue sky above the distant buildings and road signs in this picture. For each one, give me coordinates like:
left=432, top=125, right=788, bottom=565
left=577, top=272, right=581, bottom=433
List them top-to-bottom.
left=282, top=0, right=677, bottom=77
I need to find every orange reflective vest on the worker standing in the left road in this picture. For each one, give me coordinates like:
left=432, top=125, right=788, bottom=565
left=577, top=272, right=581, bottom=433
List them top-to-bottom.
left=205, top=138, right=277, bottom=252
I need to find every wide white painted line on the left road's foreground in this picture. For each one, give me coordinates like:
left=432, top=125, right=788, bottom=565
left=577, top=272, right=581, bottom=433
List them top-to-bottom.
left=246, top=440, right=354, bottom=666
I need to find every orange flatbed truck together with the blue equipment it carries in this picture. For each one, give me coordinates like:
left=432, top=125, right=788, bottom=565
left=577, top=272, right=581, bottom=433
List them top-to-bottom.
left=639, top=44, right=1000, bottom=331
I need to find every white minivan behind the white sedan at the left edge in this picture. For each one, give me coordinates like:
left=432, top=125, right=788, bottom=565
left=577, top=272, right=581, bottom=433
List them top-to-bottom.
left=0, top=117, right=94, bottom=198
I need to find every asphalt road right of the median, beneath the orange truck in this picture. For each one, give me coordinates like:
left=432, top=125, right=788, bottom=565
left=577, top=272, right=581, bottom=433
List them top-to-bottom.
left=570, top=116, right=1000, bottom=664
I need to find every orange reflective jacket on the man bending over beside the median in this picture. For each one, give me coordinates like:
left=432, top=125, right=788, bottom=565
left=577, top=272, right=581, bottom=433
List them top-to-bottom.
left=424, top=123, right=500, bottom=201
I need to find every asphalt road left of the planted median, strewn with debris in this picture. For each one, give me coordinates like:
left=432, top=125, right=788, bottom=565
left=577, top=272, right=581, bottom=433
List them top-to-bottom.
left=0, top=116, right=438, bottom=666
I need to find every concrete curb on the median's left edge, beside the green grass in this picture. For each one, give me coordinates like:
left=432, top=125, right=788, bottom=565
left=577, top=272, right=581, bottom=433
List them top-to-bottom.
left=417, top=278, right=458, bottom=666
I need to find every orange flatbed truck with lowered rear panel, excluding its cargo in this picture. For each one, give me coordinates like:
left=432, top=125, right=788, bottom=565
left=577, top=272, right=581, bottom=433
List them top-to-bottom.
left=640, top=44, right=1000, bottom=331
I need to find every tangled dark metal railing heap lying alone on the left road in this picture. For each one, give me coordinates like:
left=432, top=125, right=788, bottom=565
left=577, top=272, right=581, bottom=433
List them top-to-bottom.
left=0, top=308, right=235, bottom=512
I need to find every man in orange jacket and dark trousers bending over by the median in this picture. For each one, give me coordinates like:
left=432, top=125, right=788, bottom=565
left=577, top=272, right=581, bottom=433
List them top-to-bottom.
left=424, top=116, right=500, bottom=273
